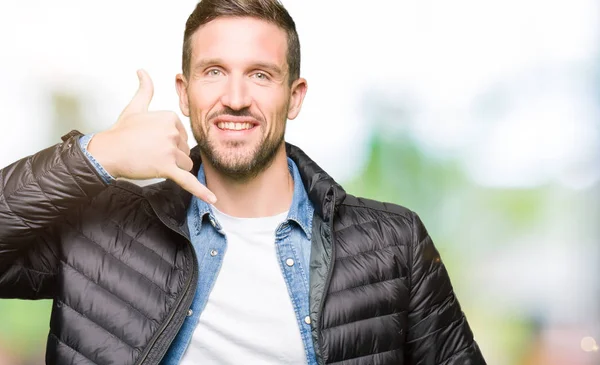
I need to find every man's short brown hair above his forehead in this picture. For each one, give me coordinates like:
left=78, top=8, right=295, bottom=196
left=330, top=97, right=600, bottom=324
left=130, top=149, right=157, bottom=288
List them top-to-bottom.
left=182, top=0, right=300, bottom=84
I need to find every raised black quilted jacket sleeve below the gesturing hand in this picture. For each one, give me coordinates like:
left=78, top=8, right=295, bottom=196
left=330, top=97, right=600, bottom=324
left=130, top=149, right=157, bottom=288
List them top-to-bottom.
left=0, top=132, right=106, bottom=299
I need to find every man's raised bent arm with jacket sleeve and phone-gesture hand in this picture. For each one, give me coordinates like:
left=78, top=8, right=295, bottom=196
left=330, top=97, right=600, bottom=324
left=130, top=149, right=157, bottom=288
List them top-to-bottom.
left=0, top=71, right=216, bottom=298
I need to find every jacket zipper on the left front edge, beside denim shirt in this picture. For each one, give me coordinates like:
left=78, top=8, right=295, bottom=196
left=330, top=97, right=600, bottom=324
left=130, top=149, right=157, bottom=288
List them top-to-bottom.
left=136, top=210, right=198, bottom=365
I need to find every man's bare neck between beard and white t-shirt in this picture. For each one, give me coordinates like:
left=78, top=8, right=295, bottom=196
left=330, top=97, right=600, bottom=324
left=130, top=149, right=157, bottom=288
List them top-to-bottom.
left=204, top=143, right=294, bottom=218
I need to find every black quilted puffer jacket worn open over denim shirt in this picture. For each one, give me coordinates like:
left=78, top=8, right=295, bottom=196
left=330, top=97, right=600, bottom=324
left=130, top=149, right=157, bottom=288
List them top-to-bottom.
left=0, top=132, right=485, bottom=365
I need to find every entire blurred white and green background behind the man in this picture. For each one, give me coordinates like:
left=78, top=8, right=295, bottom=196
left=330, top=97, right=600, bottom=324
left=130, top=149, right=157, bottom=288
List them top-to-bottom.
left=0, top=0, right=600, bottom=365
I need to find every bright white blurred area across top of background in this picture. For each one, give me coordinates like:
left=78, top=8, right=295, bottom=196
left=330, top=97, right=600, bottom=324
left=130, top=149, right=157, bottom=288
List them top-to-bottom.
left=0, top=0, right=600, bottom=187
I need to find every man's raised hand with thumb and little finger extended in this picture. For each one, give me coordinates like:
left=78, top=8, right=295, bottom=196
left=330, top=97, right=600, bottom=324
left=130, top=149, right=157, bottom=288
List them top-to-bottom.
left=88, top=70, right=216, bottom=204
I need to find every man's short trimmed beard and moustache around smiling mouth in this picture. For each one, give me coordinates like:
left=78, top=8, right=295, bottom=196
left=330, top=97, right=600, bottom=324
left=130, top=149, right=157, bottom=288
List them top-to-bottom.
left=191, top=108, right=285, bottom=182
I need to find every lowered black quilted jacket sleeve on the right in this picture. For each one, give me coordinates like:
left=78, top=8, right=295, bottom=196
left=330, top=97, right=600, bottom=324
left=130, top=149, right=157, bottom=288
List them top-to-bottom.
left=406, top=214, right=485, bottom=365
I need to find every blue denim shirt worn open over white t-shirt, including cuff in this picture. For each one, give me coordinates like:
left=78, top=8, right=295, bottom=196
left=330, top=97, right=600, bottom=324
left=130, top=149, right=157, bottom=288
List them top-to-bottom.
left=79, top=135, right=317, bottom=365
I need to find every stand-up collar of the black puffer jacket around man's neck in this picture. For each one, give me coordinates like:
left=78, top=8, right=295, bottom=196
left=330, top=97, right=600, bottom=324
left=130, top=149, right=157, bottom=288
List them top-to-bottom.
left=143, top=143, right=346, bottom=230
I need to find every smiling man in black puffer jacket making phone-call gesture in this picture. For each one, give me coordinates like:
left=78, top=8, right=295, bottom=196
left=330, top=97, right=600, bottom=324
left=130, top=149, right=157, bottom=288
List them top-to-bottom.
left=0, top=0, right=485, bottom=365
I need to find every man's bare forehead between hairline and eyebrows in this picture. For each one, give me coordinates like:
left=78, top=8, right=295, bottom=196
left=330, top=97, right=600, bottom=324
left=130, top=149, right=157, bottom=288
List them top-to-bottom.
left=191, top=17, right=287, bottom=67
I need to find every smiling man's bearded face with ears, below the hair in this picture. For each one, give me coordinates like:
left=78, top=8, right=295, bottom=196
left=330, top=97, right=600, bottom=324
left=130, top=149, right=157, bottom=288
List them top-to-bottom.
left=177, top=17, right=306, bottom=180
